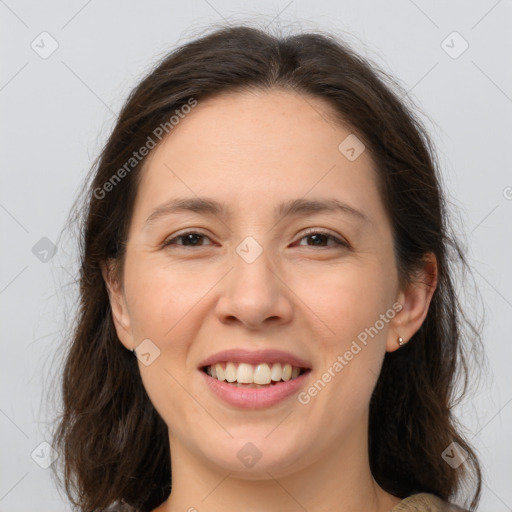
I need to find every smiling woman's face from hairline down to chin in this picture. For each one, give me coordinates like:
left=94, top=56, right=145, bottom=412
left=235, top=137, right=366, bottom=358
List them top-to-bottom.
left=104, top=91, right=428, bottom=478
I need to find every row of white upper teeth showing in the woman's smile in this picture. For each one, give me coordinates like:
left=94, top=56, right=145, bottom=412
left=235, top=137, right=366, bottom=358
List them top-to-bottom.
left=206, top=362, right=301, bottom=385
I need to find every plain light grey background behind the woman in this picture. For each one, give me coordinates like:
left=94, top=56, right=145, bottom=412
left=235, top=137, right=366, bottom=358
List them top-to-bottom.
left=0, top=0, right=512, bottom=512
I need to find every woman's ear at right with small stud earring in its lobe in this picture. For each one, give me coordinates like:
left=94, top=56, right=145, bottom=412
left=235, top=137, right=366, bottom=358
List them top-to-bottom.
left=386, top=253, right=438, bottom=352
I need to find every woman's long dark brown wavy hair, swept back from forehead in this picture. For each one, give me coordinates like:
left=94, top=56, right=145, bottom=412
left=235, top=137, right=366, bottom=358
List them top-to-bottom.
left=53, top=25, right=481, bottom=512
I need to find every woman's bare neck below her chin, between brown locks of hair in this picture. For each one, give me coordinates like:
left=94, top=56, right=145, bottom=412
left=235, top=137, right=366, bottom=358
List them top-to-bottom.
left=153, top=416, right=400, bottom=512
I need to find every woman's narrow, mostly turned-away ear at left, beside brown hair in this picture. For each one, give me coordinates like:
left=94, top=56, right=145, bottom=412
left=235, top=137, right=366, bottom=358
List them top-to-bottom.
left=101, top=259, right=135, bottom=350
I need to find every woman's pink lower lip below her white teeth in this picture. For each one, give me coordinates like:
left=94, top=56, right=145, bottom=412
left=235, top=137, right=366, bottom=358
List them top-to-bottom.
left=199, top=370, right=311, bottom=409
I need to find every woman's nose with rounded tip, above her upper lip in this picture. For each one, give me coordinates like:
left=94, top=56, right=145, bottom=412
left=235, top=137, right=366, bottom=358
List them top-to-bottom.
left=216, top=245, right=293, bottom=330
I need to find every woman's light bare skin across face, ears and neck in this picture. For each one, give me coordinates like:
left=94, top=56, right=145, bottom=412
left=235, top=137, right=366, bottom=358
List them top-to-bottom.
left=103, top=90, right=437, bottom=512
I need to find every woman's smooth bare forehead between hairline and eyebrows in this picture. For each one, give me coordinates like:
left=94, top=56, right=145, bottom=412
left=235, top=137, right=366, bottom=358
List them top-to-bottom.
left=130, top=91, right=379, bottom=226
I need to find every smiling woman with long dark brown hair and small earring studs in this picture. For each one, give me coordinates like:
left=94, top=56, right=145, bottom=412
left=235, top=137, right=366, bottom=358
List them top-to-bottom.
left=54, top=26, right=481, bottom=512
